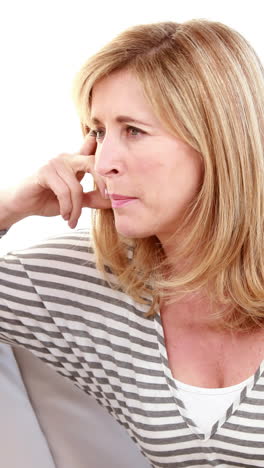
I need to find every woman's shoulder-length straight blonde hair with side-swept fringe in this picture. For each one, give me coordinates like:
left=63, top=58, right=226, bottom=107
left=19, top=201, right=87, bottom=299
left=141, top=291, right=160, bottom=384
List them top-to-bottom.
left=73, top=19, right=264, bottom=330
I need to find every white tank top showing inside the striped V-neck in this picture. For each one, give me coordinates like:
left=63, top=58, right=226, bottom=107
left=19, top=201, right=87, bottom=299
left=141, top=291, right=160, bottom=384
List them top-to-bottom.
left=174, top=375, right=254, bottom=434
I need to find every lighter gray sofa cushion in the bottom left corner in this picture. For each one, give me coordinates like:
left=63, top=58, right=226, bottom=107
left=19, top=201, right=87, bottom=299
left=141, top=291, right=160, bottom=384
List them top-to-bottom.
left=0, top=344, right=56, bottom=468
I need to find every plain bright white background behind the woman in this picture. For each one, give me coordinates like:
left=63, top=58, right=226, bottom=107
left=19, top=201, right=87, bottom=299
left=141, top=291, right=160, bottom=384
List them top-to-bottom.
left=0, top=0, right=264, bottom=251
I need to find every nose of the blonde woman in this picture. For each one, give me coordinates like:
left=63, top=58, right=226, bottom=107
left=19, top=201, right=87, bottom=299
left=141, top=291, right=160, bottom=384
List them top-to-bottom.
left=94, top=137, right=124, bottom=178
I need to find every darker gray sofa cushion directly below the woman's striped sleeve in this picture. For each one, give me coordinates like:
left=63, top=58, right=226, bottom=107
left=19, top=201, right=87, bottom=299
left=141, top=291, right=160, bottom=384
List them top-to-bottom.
left=12, top=348, right=150, bottom=468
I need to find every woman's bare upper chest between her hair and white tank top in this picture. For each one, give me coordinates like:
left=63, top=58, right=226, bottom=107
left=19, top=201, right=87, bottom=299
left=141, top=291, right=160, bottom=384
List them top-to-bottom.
left=162, top=308, right=264, bottom=388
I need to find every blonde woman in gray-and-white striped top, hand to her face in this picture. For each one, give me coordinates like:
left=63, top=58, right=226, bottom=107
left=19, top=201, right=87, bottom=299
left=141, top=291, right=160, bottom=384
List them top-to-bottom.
left=0, top=20, right=264, bottom=467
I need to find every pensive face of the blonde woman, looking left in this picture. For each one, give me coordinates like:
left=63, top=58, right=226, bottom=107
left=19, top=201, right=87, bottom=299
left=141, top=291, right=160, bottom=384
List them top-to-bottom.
left=90, top=70, right=202, bottom=247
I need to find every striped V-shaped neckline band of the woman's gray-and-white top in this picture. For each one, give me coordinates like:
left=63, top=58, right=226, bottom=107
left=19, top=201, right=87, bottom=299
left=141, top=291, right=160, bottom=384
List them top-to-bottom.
left=154, top=306, right=264, bottom=441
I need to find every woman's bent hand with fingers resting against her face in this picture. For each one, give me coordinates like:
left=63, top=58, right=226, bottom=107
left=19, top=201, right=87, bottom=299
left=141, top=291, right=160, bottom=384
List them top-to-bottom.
left=4, top=135, right=111, bottom=228
